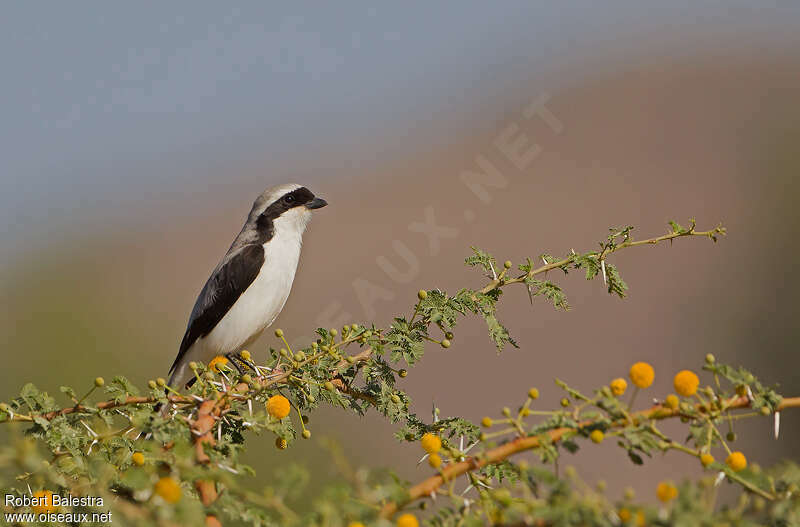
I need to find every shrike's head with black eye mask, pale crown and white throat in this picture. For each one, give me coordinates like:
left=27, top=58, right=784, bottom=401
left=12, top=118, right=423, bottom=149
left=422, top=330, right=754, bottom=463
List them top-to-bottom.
left=249, top=183, right=328, bottom=234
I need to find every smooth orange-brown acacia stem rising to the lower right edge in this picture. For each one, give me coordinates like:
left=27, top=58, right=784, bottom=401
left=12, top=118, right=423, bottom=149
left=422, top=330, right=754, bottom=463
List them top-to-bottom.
left=380, top=397, right=800, bottom=518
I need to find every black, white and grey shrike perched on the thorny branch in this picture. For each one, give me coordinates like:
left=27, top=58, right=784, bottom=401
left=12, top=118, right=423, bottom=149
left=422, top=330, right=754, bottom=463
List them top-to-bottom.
left=168, top=183, right=328, bottom=389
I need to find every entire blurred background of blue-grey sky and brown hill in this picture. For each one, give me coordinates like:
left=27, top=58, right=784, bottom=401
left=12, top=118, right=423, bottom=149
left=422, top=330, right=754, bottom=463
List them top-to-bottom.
left=0, top=2, right=800, bottom=508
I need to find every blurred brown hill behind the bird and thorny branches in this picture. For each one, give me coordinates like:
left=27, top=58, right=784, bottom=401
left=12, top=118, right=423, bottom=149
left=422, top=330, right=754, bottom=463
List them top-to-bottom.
left=0, top=57, right=800, bottom=502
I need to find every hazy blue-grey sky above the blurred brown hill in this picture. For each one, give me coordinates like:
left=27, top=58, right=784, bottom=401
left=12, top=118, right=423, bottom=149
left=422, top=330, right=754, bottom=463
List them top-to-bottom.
left=0, top=2, right=800, bottom=254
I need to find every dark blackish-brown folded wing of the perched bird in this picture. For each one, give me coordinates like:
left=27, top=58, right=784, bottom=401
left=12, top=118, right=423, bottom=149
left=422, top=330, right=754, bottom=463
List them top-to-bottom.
left=169, top=245, right=264, bottom=373
